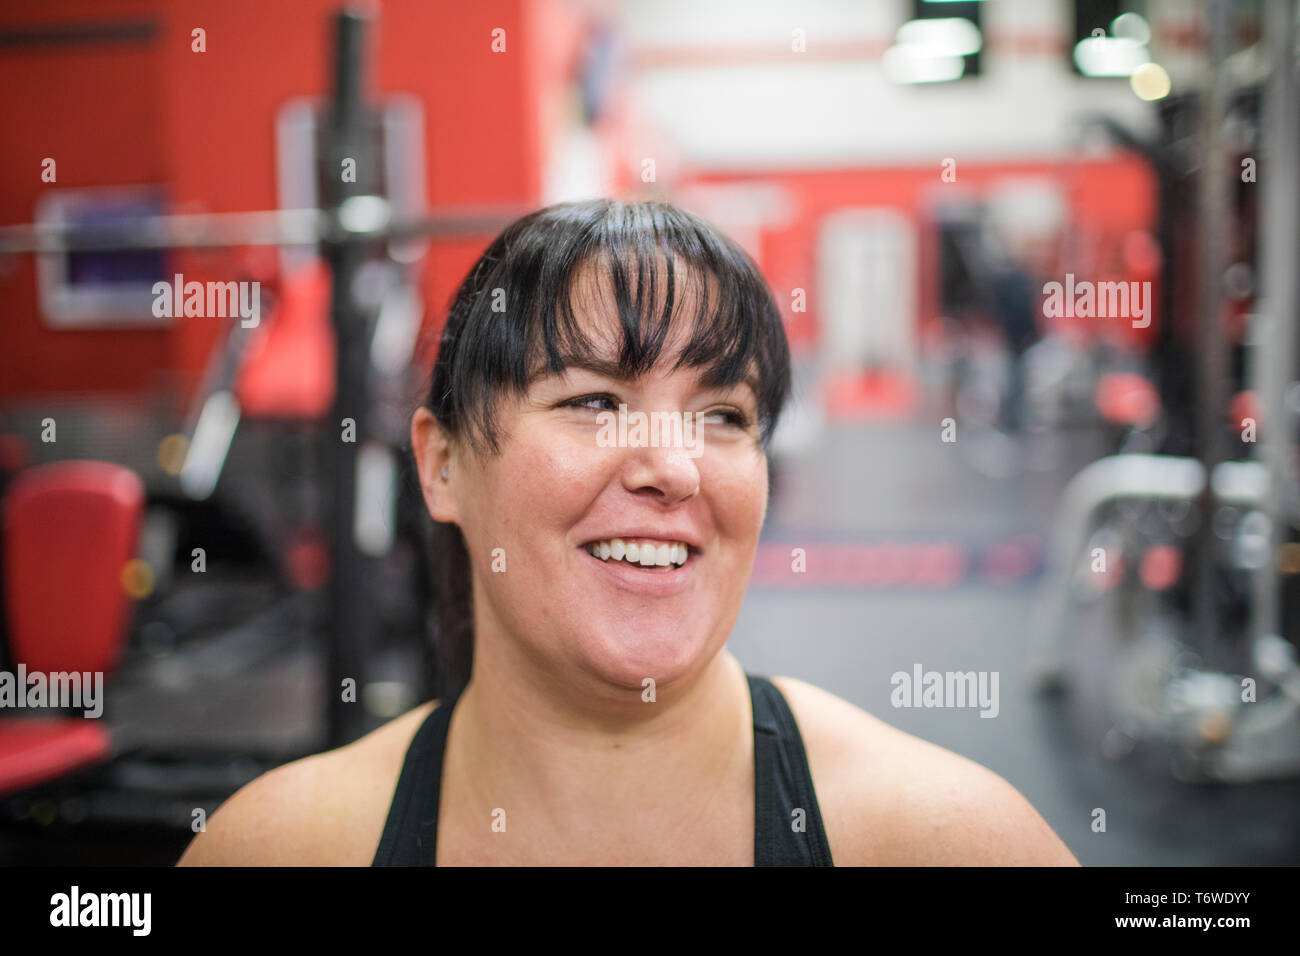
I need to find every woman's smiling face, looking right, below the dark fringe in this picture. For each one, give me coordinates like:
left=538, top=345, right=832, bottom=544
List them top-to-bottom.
left=413, top=273, right=767, bottom=688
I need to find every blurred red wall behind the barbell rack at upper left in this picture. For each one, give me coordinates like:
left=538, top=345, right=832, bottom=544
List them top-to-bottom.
left=0, top=0, right=577, bottom=397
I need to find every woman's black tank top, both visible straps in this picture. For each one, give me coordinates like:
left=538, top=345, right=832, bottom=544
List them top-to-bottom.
left=372, top=674, right=835, bottom=866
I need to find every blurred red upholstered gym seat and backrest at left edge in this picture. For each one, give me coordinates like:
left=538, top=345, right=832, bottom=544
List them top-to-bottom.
left=0, top=462, right=144, bottom=793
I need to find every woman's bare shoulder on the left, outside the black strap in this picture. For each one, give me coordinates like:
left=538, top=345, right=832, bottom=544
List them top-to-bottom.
left=177, top=701, right=438, bottom=866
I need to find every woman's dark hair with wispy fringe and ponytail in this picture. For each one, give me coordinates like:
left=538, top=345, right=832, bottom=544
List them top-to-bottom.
left=426, top=199, right=790, bottom=697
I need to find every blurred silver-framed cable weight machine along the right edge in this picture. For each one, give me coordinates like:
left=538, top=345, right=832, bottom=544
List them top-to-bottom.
left=1034, top=0, right=1300, bottom=782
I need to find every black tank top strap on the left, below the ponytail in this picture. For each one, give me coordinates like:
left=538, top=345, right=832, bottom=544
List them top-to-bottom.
left=371, top=695, right=459, bottom=866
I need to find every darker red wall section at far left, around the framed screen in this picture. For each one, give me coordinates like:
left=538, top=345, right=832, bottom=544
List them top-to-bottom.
left=0, top=0, right=170, bottom=395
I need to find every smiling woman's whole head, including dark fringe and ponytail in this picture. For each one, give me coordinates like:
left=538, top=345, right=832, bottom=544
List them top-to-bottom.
left=412, top=202, right=790, bottom=712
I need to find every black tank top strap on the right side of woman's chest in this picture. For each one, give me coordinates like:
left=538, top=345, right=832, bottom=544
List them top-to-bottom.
left=745, top=674, right=835, bottom=866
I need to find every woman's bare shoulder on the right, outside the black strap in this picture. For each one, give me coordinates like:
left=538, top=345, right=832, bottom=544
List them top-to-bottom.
left=772, top=678, right=1078, bottom=866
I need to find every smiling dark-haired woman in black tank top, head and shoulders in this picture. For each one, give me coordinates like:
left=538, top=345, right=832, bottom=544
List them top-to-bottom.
left=181, top=200, right=1076, bottom=866
